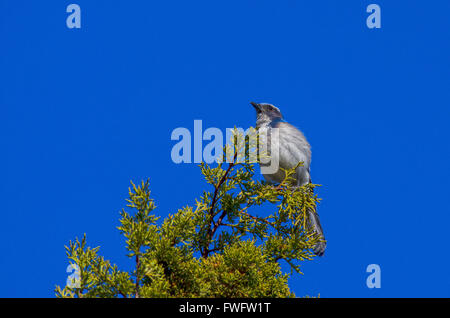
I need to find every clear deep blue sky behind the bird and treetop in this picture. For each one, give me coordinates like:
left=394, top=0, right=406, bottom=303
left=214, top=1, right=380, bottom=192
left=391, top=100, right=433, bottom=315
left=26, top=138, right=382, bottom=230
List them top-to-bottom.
left=0, top=0, right=450, bottom=297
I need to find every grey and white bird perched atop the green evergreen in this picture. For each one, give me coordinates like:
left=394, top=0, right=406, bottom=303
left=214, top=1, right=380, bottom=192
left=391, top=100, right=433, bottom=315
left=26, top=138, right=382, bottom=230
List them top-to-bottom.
left=250, top=102, right=327, bottom=256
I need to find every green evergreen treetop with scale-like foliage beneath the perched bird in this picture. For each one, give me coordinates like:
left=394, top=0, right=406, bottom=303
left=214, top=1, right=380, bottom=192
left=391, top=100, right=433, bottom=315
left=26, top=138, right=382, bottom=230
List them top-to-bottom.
left=55, top=130, right=320, bottom=298
